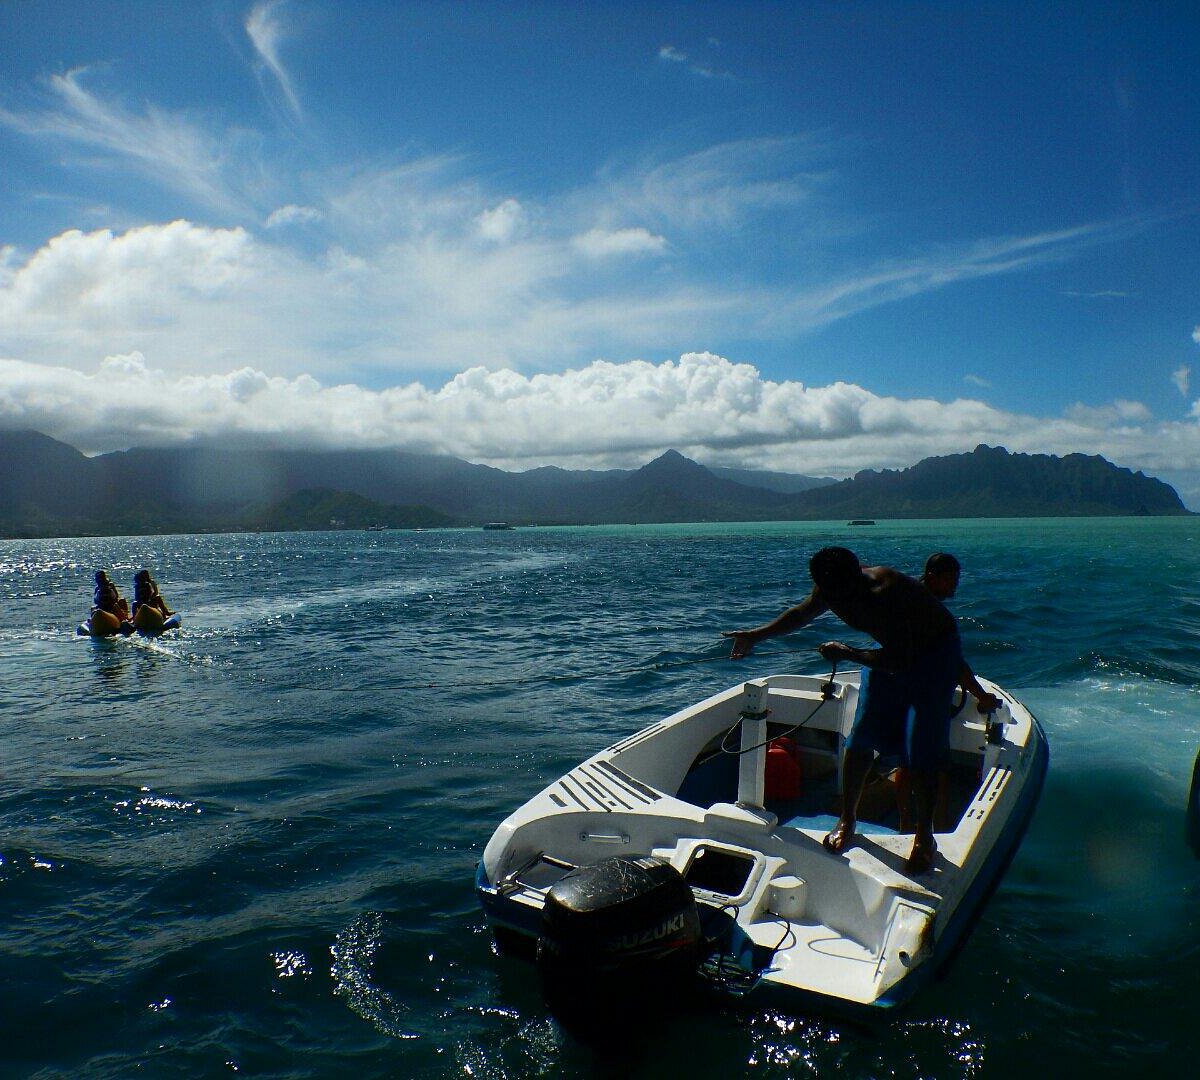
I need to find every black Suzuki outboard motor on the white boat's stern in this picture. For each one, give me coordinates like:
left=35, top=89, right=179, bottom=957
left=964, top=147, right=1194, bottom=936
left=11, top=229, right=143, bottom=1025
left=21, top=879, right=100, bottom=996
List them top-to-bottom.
left=538, top=856, right=703, bottom=1019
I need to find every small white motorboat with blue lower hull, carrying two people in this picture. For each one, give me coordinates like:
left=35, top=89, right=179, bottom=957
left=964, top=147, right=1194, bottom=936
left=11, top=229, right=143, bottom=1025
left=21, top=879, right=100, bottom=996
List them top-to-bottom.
left=476, top=671, right=1049, bottom=1010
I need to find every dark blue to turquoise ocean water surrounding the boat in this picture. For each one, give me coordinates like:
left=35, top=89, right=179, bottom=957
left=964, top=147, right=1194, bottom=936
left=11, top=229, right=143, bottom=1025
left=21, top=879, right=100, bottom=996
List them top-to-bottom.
left=0, top=518, right=1200, bottom=1078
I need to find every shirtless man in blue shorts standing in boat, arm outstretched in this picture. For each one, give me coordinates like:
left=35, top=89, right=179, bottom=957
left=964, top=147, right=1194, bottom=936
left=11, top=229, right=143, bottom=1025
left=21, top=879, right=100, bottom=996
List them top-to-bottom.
left=725, top=547, right=962, bottom=874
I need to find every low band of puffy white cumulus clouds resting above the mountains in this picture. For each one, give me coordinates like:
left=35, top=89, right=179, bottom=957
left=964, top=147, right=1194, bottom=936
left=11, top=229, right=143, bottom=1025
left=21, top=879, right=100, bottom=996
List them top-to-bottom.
left=0, top=353, right=1200, bottom=511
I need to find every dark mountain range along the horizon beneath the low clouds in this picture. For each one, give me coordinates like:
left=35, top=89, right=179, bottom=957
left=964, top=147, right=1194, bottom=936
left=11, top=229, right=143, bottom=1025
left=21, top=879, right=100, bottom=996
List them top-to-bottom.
left=0, top=431, right=1188, bottom=536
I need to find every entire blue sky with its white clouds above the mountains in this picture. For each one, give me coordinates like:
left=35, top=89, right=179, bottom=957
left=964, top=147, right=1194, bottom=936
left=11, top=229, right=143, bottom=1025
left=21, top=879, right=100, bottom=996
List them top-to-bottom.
left=0, top=0, right=1200, bottom=508
